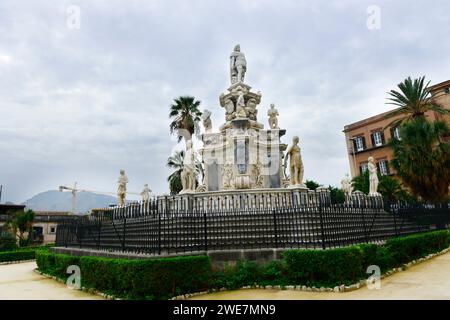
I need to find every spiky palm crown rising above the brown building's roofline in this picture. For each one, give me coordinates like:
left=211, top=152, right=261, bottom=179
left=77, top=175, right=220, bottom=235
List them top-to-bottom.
left=385, top=76, right=449, bottom=126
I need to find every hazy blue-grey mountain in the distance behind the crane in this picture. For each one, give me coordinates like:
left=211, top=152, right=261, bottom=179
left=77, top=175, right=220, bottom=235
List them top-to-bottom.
left=23, top=190, right=117, bottom=213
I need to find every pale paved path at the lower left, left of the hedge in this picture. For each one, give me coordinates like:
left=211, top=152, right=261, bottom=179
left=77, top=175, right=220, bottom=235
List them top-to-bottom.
left=0, top=262, right=102, bottom=300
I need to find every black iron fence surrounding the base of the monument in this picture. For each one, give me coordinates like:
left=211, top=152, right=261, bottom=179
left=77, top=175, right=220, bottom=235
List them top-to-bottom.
left=56, top=197, right=450, bottom=255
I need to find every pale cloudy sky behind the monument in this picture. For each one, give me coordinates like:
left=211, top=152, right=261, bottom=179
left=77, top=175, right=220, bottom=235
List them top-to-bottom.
left=0, top=0, right=450, bottom=202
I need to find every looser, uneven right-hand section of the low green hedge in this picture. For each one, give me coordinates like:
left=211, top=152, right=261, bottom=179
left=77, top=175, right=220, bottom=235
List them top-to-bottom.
left=211, top=231, right=450, bottom=289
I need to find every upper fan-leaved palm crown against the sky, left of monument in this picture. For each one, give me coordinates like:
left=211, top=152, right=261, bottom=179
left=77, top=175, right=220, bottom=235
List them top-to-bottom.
left=169, top=96, right=202, bottom=142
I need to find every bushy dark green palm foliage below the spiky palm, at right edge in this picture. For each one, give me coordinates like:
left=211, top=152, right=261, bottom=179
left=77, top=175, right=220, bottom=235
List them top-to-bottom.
left=390, top=117, right=450, bottom=202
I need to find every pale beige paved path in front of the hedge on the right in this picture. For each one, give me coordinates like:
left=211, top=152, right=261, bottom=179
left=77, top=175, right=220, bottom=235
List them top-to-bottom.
left=192, top=252, right=450, bottom=300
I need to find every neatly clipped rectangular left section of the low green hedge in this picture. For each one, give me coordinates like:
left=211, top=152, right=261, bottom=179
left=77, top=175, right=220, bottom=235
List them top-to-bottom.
left=36, top=250, right=211, bottom=299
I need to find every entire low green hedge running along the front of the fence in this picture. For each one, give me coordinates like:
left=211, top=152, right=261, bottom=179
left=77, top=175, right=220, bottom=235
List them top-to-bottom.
left=36, top=231, right=450, bottom=299
